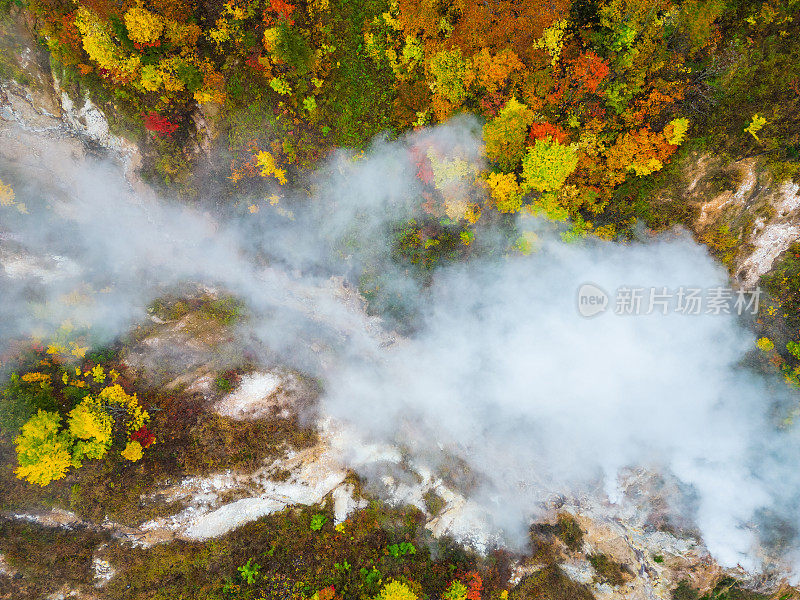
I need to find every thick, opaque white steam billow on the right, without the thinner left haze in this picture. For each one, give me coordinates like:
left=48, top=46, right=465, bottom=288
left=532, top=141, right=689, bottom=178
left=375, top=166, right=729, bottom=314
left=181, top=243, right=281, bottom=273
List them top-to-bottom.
left=326, top=238, right=798, bottom=568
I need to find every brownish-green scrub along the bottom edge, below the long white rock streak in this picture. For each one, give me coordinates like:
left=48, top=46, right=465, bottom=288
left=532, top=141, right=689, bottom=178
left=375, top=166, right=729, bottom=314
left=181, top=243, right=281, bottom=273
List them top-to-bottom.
left=105, top=503, right=493, bottom=600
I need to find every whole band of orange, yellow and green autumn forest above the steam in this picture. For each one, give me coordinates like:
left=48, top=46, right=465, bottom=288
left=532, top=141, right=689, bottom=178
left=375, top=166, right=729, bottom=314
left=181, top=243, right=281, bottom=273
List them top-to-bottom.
left=21, top=0, right=794, bottom=239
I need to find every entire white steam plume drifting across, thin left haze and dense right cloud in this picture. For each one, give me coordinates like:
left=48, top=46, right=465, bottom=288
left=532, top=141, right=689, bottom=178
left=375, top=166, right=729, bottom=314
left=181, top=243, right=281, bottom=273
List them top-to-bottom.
left=0, top=116, right=800, bottom=568
